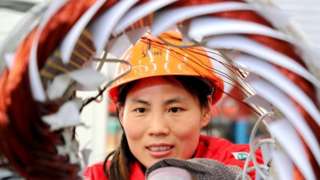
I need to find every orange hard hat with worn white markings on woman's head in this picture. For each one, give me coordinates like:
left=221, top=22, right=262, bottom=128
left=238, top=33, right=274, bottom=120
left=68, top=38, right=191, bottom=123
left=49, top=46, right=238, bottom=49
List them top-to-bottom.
left=107, top=31, right=223, bottom=104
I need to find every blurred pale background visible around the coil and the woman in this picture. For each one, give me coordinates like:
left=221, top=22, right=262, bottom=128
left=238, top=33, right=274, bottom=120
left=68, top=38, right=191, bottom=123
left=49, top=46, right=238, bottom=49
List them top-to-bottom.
left=0, top=0, right=320, bottom=167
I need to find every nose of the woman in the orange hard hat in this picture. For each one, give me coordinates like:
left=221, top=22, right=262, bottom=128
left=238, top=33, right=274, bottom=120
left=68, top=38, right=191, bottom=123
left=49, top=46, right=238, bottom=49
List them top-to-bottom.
left=148, top=113, right=170, bottom=136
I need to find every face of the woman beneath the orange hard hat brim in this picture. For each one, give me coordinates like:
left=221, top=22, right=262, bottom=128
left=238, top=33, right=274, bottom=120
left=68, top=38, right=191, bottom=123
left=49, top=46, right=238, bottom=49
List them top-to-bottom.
left=119, top=77, right=210, bottom=168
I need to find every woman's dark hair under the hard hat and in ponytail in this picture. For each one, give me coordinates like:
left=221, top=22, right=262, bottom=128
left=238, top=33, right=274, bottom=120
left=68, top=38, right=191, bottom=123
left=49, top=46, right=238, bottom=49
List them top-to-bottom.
left=104, top=76, right=213, bottom=180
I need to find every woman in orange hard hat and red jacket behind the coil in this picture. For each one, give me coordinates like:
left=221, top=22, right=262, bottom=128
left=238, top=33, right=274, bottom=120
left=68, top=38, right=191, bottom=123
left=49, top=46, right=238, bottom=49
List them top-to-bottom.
left=85, top=32, right=262, bottom=180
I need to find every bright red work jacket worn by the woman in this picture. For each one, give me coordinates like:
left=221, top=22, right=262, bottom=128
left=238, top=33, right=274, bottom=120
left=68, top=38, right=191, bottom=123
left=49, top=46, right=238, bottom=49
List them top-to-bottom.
left=84, top=135, right=262, bottom=180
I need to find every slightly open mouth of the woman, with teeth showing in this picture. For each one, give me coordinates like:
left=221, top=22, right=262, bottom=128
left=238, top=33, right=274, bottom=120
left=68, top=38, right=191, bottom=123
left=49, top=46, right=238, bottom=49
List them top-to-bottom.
left=146, top=144, right=174, bottom=158
